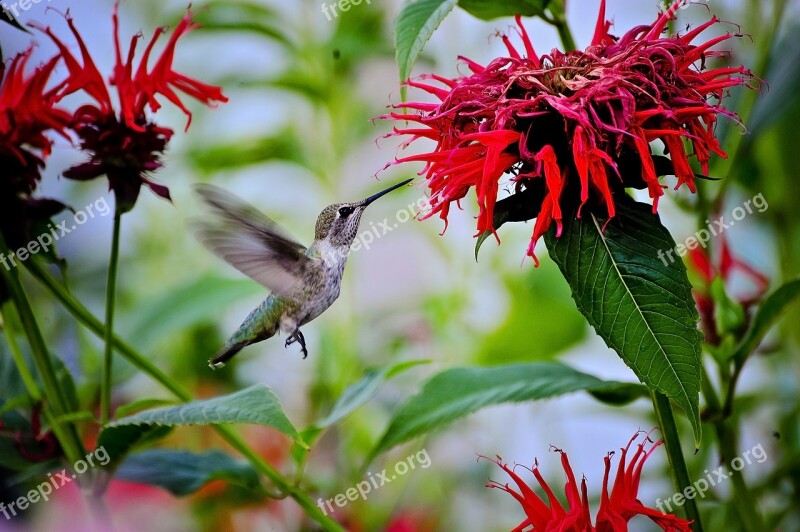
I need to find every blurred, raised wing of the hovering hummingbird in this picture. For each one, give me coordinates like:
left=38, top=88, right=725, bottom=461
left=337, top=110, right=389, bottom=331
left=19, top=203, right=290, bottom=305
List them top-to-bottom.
left=195, top=185, right=312, bottom=296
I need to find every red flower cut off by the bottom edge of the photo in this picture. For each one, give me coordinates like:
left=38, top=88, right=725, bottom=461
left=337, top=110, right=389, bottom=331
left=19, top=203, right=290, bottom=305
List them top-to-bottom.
left=487, top=434, right=690, bottom=532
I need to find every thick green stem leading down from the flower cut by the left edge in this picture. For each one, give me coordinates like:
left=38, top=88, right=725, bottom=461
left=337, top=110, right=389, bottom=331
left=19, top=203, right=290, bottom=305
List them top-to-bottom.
left=0, top=235, right=86, bottom=464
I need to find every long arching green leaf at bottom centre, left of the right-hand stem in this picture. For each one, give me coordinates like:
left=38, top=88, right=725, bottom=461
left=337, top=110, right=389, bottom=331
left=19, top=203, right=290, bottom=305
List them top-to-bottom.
left=369, top=362, right=636, bottom=462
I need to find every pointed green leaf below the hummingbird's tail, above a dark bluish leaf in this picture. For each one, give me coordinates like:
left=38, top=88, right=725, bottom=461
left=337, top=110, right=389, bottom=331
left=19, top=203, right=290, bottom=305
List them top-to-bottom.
left=107, top=384, right=300, bottom=441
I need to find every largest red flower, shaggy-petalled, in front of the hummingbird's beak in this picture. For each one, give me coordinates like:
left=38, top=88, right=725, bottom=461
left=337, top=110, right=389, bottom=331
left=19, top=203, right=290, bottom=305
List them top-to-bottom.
left=383, top=0, right=753, bottom=264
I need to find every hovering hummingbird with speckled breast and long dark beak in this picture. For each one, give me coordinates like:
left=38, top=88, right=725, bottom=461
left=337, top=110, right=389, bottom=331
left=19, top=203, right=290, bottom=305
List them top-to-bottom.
left=195, top=179, right=413, bottom=369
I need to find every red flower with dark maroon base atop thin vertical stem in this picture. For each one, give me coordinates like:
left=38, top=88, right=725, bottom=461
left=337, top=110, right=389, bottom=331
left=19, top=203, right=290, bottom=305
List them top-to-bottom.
left=34, top=4, right=228, bottom=212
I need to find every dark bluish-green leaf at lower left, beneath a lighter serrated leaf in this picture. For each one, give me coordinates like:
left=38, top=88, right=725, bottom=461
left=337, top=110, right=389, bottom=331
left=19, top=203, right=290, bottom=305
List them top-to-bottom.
left=116, top=449, right=261, bottom=497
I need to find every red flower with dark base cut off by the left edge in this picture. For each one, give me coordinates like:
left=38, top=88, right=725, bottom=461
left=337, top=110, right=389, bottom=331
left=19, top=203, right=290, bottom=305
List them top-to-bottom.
left=0, top=44, right=70, bottom=248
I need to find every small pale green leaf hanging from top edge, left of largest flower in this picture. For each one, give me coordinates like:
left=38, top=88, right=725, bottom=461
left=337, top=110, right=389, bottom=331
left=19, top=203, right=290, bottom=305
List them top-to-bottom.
left=395, top=0, right=456, bottom=96
